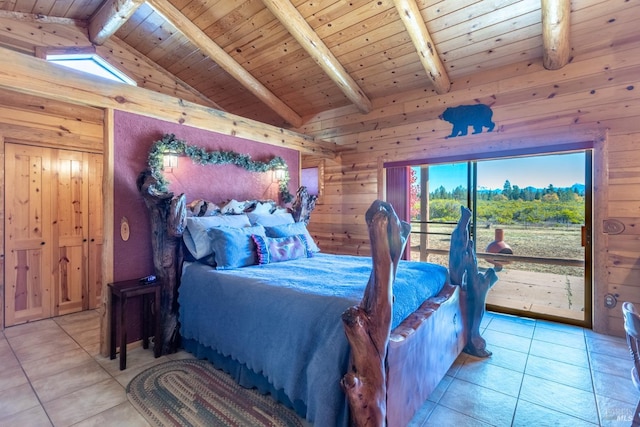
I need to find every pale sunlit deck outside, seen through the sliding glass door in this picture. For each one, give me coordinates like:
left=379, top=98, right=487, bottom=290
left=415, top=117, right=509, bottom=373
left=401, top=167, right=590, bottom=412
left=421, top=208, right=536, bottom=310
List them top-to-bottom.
left=486, top=267, right=585, bottom=321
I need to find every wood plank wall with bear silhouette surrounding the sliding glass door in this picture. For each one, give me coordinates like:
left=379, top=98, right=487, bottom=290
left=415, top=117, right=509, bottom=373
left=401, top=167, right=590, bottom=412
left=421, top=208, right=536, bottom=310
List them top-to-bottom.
left=300, top=37, right=640, bottom=335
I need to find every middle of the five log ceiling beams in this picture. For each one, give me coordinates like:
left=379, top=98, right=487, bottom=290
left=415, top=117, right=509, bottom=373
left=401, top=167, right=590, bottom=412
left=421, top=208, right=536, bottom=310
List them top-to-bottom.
left=262, top=0, right=371, bottom=114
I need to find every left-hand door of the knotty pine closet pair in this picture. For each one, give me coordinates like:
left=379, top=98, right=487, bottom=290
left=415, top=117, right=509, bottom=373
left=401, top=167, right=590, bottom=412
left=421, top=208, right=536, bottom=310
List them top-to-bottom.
left=5, top=144, right=54, bottom=326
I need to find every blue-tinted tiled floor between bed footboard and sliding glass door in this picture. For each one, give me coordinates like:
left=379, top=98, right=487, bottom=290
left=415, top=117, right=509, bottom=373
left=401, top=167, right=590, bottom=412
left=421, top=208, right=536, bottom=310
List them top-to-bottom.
left=412, top=313, right=640, bottom=427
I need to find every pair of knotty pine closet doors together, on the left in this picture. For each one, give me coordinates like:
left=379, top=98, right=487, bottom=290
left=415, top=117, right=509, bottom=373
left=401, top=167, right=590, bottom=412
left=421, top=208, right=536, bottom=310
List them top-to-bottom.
left=5, top=143, right=103, bottom=326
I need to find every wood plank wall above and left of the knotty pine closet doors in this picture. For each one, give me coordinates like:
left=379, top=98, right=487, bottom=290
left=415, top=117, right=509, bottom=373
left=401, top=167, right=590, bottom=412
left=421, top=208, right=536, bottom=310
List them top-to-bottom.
left=0, top=90, right=104, bottom=329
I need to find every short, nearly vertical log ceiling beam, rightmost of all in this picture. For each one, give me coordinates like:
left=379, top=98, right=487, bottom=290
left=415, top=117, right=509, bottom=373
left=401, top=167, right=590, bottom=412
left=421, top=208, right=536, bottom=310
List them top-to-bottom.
left=542, top=0, right=571, bottom=70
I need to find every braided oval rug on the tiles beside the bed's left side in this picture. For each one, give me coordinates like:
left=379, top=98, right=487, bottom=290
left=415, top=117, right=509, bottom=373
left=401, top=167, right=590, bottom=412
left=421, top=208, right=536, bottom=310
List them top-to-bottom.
left=127, top=359, right=303, bottom=427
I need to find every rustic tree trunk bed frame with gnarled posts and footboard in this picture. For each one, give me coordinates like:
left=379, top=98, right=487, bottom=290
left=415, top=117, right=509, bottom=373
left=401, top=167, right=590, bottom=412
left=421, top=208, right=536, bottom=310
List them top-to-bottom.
left=137, top=171, right=497, bottom=426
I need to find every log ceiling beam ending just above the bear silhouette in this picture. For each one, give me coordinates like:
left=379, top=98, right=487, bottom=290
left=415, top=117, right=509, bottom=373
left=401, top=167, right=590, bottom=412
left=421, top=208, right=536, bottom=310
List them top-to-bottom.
left=393, top=0, right=451, bottom=94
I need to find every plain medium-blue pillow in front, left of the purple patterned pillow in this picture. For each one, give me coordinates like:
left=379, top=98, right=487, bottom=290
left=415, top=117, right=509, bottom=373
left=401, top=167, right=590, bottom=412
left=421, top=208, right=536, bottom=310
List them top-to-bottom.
left=207, top=225, right=266, bottom=270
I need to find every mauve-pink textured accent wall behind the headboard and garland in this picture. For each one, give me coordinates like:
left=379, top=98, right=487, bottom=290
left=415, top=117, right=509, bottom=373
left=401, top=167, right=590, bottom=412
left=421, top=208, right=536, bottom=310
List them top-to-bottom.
left=113, top=111, right=300, bottom=281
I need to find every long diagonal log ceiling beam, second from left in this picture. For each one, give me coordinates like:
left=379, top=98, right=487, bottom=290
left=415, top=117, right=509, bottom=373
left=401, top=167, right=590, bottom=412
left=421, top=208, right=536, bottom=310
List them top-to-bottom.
left=147, top=0, right=303, bottom=128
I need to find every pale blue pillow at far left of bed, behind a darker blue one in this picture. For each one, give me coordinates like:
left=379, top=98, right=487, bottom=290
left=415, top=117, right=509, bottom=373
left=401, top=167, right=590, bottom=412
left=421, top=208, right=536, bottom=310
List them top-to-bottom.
left=182, top=215, right=251, bottom=259
